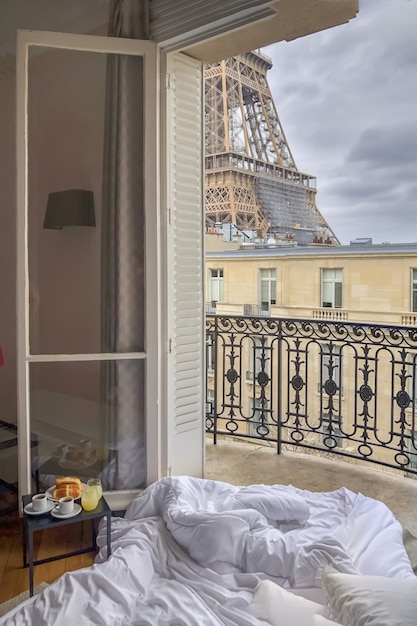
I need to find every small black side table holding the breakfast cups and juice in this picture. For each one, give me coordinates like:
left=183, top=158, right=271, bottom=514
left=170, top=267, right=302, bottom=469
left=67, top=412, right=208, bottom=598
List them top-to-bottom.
left=22, top=495, right=111, bottom=596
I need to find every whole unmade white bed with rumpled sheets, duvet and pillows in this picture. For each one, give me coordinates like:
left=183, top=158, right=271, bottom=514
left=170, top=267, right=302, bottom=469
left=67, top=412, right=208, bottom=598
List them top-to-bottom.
left=0, top=477, right=417, bottom=626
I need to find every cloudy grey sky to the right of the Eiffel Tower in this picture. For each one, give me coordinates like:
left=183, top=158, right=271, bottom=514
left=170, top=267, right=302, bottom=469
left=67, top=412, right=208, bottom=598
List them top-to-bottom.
left=263, top=0, right=417, bottom=244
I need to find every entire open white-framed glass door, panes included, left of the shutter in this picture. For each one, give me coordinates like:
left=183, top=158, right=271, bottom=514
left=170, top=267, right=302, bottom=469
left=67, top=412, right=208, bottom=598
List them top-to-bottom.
left=17, top=31, right=159, bottom=502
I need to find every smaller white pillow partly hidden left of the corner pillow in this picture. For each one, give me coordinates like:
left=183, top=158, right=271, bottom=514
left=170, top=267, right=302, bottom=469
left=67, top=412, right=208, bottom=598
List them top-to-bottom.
left=248, top=580, right=335, bottom=626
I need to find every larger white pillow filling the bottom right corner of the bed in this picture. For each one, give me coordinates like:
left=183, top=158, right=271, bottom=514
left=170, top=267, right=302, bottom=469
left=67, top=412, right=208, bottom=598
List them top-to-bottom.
left=321, top=565, right=417, bottom=626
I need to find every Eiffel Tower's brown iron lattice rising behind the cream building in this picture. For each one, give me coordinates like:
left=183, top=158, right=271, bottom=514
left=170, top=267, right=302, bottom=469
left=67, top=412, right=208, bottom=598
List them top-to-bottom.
left=205, top=50, right=340, bottom=245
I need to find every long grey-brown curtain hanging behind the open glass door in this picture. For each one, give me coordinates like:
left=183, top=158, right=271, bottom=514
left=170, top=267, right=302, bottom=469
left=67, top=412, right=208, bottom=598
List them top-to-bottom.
left=101, top=0, right=147, bottom=489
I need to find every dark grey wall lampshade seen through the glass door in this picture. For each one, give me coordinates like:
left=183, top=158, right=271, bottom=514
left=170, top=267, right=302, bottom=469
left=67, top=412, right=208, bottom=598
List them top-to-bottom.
left=43, top=189, right=96, bottom=228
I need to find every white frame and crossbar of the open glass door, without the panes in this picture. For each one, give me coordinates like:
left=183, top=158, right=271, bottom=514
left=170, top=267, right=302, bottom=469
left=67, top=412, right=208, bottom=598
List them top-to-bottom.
left=16, top=31, right=161, bottom=495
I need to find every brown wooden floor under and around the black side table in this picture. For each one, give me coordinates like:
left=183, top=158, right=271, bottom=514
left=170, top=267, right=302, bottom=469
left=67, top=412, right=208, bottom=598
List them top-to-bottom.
left=0, top=511, right=94, bottom=604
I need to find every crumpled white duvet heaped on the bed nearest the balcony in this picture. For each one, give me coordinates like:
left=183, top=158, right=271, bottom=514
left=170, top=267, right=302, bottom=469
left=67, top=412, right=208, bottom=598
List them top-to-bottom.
left=125, top=477, right=412, bottom=587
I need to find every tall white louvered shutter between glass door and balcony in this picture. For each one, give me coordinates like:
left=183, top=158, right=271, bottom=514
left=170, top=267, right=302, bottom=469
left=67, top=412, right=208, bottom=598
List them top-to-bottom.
left=166, top=53, right=205, bottom=476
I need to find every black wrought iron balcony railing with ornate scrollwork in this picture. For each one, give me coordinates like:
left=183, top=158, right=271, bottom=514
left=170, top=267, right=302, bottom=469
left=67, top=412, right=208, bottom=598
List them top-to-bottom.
left=206, top=315, right=417, bottom=476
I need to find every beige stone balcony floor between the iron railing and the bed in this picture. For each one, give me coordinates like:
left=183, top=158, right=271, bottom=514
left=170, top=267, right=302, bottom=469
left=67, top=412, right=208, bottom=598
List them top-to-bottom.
left=205, top=435, right=417, bottom=536
